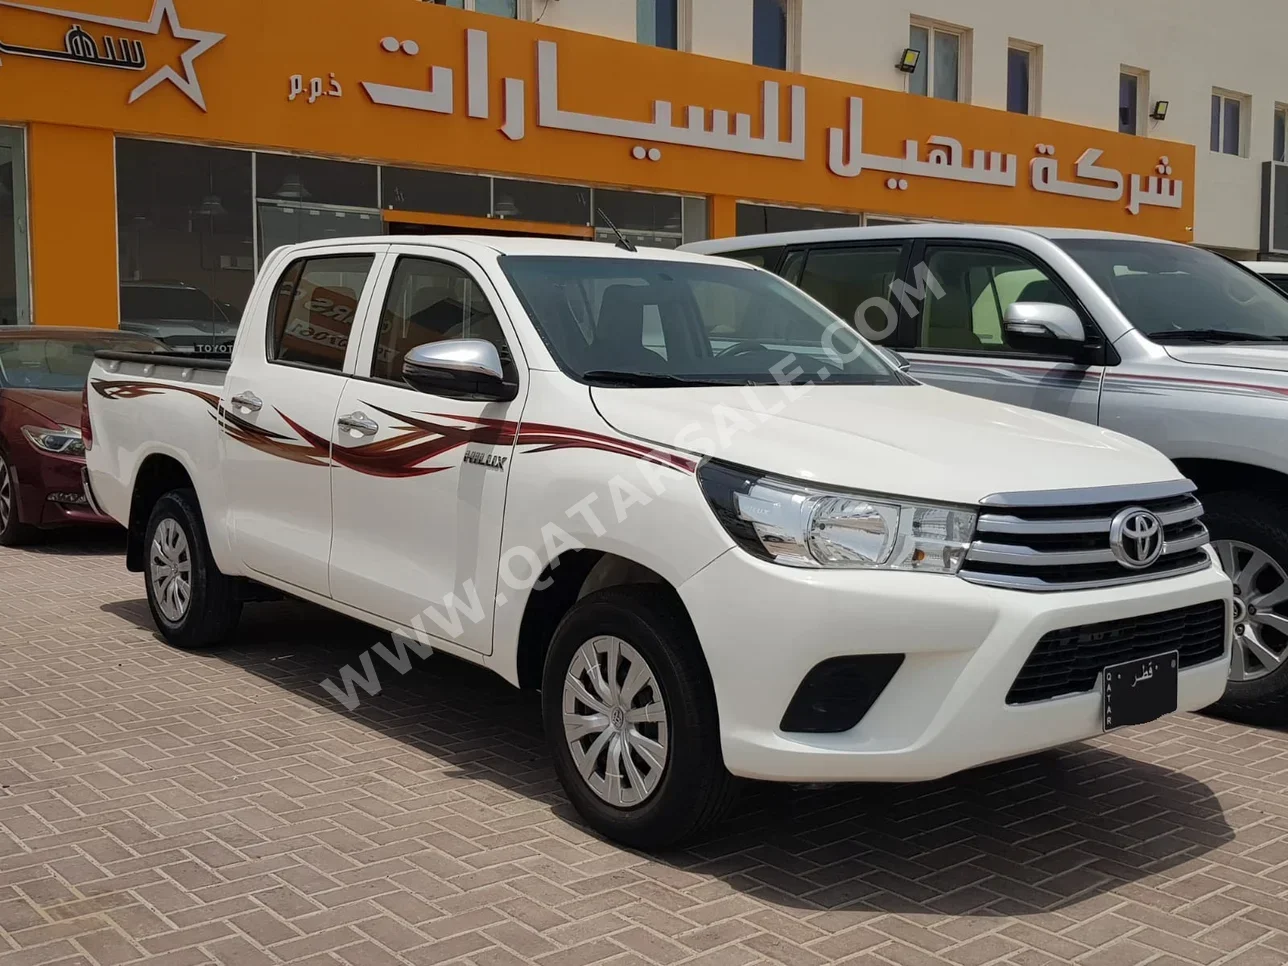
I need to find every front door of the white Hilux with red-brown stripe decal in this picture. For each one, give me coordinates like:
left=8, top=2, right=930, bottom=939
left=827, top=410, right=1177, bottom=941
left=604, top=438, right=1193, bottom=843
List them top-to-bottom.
left=331, top=246, right=526, bottom=653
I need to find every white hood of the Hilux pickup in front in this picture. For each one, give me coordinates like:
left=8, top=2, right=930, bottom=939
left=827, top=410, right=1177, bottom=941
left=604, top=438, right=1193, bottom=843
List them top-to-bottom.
left=591, top=385, right=1180, bottom=504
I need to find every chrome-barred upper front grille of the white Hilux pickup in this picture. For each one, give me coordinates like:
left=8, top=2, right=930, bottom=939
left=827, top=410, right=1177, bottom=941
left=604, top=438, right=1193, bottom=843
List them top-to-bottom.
left=960, top=480, right=1211, bottom=591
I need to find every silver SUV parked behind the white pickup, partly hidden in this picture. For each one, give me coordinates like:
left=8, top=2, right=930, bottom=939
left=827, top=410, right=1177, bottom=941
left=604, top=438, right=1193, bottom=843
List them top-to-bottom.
left=687, top=224, right=1288, bottom=712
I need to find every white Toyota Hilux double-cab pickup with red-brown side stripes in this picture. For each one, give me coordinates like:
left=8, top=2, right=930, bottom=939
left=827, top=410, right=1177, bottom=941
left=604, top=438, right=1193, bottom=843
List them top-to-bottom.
left=81, top=237, right=1231, bottom=848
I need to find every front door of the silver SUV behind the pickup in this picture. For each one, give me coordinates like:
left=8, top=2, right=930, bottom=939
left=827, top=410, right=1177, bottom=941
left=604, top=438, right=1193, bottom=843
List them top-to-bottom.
left=904, top=241, right=1104, bottom=422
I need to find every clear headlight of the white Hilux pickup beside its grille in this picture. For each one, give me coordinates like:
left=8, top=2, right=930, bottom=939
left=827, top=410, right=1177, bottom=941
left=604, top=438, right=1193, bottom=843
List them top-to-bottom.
left=698, top=460, right=975, bottom=573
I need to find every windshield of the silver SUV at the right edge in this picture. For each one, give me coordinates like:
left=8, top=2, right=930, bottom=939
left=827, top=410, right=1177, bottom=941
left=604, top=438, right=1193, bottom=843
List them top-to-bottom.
left=1056, top=238, right=1288, bottom=343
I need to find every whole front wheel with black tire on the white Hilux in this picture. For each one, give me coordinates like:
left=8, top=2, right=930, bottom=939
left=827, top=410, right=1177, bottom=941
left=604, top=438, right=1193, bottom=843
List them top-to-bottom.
left=541, top=586, right=737, bottom=849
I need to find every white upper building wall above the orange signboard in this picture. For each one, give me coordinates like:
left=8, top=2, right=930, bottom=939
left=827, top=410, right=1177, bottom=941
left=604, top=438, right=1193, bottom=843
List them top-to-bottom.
left=531, top=0, right=1288, bottom=251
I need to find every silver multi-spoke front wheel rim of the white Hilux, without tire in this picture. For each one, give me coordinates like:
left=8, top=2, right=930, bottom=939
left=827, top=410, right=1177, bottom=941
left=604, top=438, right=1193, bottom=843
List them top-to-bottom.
left=563, top=636, right=670, bottom=808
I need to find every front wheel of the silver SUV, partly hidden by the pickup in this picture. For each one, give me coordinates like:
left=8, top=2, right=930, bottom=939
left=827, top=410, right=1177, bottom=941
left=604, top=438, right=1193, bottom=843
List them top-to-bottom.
left=1203, top=491, right=1288, bottom=720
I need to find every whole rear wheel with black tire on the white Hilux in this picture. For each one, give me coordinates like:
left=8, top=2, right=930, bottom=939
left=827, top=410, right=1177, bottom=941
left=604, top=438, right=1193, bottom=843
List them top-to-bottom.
left=143, top=489, right=242, bottom=650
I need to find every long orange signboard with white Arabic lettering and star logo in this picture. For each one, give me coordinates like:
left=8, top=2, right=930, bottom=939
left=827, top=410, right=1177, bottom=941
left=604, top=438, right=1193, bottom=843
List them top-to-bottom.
left=0, top=0, right=1194, bottom=240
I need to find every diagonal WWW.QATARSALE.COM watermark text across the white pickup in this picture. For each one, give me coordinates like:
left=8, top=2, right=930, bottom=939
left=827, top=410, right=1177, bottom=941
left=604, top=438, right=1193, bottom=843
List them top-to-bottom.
left=321, top=264, right=944, bottom=711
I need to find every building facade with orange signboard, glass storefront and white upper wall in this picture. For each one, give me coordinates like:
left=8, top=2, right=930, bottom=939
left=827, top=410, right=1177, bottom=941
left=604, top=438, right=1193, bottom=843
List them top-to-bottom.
left=0, top=0, right=1246, bottom=327
